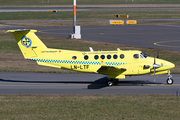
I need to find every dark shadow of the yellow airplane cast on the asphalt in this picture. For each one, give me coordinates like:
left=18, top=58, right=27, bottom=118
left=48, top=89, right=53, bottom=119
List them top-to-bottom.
left=0, top=77, right=163, bottom=89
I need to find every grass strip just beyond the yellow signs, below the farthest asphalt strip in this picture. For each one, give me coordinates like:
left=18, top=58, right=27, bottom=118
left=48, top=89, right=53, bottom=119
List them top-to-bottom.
left=0, top=9, right=180, bottom=20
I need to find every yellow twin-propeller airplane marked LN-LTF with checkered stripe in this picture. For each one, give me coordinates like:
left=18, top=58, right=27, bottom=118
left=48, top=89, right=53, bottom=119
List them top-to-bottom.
left=7, top=29, right=175, bottom=86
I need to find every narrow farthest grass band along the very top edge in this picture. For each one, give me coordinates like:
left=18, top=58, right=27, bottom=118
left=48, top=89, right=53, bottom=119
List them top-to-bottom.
left=0, top=0, right=180, bottom=5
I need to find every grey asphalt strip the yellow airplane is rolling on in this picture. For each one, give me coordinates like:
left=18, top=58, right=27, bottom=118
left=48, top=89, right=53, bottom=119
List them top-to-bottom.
left=0, top=72, right=180, bottom=95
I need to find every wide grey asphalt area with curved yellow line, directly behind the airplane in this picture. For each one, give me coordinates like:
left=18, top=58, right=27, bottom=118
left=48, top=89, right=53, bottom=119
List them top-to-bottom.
left=0, top=25, right=180, bottom=51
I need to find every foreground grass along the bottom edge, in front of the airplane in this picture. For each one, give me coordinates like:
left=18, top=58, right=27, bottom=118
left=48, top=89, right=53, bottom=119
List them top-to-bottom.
left=0, top=95, right=180, bottom=120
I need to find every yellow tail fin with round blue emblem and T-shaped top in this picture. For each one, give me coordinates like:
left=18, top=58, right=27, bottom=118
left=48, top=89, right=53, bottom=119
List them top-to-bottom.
left=7, top=29, right=48, bottom=58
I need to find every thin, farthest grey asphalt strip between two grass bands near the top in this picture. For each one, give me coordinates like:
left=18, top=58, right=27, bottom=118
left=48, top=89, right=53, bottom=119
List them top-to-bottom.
left=0, top=6, right=180, bottom=12
